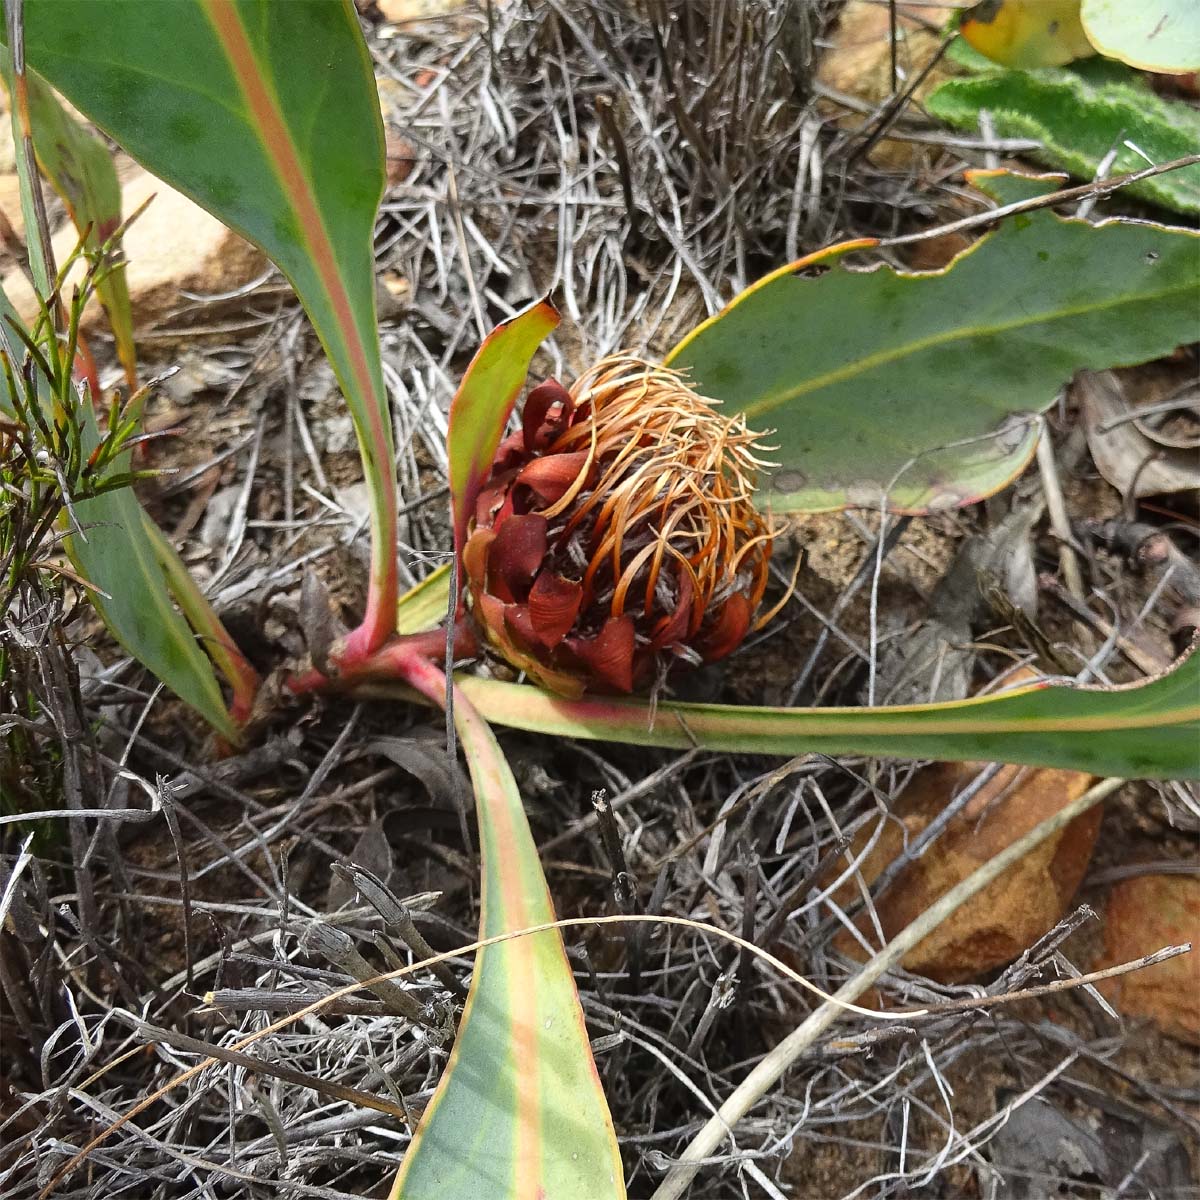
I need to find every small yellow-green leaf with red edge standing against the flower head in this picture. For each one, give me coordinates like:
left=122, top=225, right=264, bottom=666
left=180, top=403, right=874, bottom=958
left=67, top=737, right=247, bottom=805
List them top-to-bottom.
left=446, top=299, right=559, bottom=564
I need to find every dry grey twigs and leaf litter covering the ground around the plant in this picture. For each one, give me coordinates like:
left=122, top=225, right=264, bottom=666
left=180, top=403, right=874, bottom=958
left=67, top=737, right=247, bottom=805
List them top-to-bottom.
left=0, top=0, right=1200, bottom=1200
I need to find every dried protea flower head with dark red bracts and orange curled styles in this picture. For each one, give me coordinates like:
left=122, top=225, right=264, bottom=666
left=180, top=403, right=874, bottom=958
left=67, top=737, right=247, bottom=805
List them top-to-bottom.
left=463, top=355, right=772, bottom=696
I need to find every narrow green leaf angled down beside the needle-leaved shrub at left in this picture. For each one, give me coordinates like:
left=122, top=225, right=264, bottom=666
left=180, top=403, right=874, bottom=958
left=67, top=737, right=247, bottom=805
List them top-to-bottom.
left=66, top=406, right=240, bottom=742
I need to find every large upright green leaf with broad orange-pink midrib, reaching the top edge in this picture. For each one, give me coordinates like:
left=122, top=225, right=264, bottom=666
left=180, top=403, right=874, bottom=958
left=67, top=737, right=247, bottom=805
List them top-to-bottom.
left=14, top=0, right=397, bottom=649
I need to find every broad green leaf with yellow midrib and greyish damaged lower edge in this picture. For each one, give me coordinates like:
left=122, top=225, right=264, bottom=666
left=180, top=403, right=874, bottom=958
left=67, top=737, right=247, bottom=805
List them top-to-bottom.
left=668, top=187, right=1198, bottom=512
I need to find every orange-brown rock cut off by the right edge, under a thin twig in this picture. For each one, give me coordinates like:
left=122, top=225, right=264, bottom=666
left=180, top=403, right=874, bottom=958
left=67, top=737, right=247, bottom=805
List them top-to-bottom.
left=1097, top=875, right=1200, bottom=1045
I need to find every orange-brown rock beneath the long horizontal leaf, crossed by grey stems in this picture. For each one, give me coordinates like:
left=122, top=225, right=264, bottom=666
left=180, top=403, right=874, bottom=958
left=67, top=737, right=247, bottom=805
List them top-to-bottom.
left=835, top=763, right=1100, bottom=983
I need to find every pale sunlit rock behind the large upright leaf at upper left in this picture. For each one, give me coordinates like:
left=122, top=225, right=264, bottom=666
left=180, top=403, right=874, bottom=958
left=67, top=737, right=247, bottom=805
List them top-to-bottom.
left=4, top=168, right=266, bottom=332
